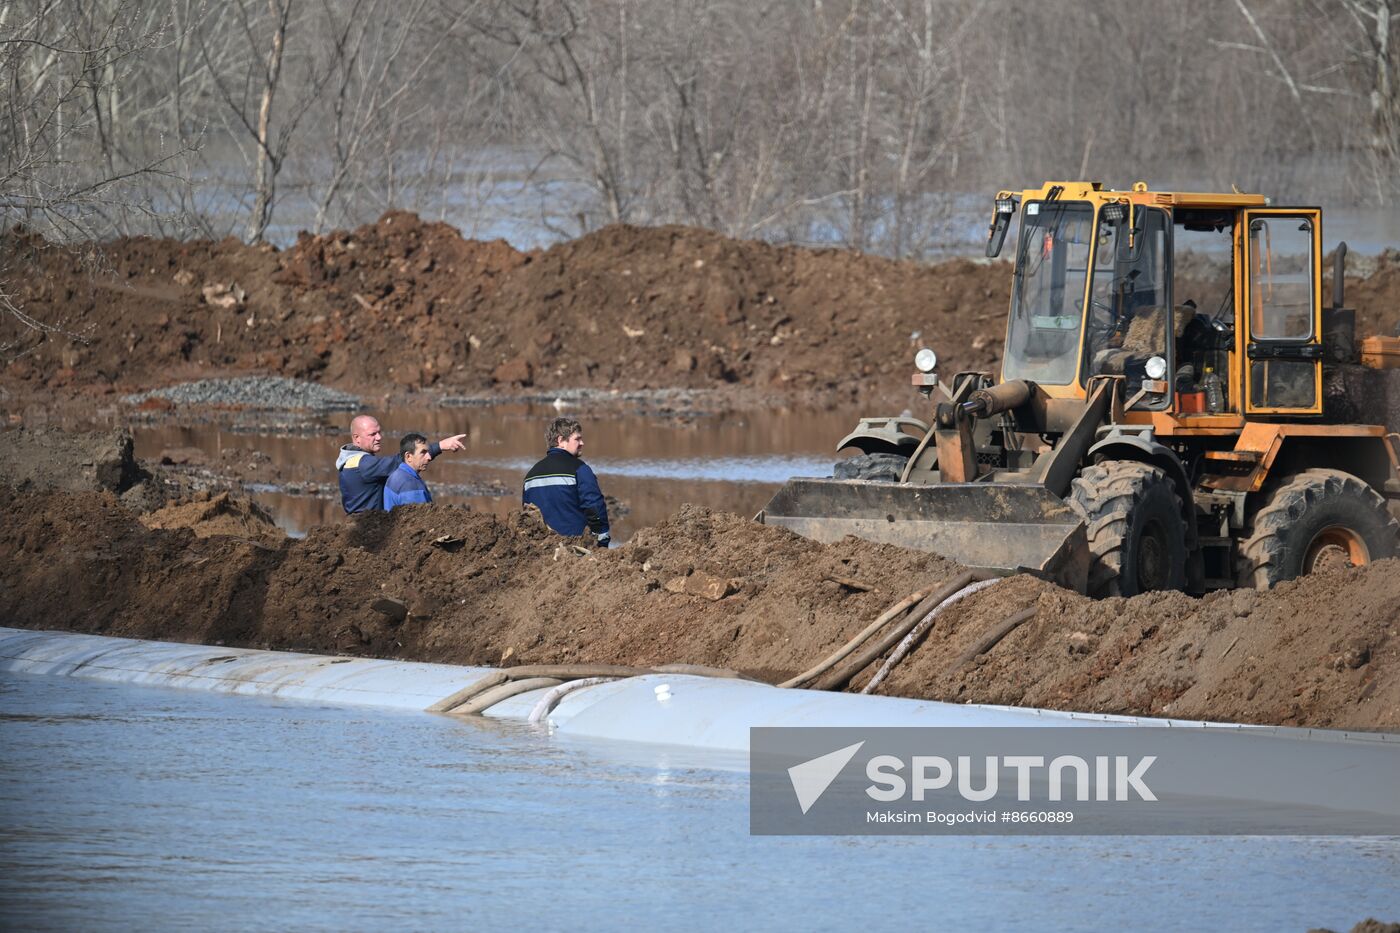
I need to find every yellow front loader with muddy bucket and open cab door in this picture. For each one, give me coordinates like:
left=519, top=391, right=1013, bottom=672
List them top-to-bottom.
left=759, top=182, right=1400, bottom=595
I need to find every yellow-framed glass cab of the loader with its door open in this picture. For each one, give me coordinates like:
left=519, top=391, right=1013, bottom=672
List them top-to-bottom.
left=988, top=182, right=1322, bottom=417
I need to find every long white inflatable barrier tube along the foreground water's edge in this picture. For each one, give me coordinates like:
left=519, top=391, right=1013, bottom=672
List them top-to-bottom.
left=0, top=628, right=1400, bottom=752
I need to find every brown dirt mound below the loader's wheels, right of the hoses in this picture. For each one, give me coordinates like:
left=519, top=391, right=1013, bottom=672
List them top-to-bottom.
left=879, top=560, right=1400, bottom=730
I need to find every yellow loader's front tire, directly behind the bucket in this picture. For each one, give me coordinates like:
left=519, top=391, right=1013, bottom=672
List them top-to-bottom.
left=1070, top=459, right=1186, bottom=597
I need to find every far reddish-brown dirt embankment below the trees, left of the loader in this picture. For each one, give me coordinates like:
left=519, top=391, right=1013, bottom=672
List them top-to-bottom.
left=0, top=212, right=1009, bottom=398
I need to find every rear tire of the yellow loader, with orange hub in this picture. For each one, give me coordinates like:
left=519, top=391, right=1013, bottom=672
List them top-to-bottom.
left=1236, top=469, right=1400, bottom=590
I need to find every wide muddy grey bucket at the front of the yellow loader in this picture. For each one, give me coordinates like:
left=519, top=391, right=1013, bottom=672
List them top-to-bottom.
left=759, top=479, right=1089, bottom=593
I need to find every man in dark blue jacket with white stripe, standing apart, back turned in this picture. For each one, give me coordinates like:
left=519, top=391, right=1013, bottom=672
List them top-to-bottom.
left=524, top=417, right=612, bottom=548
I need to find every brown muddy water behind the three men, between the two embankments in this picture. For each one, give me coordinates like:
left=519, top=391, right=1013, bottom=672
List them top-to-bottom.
left=132, top=403, right=869, bottom=541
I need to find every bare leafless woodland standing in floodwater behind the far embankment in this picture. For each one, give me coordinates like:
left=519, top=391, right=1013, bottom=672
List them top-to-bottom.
left=8, top=0, right=1400, bottom=273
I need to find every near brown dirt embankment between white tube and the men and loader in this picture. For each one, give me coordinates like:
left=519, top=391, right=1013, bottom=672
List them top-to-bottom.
left=0, top=467, right=1400, bottom=731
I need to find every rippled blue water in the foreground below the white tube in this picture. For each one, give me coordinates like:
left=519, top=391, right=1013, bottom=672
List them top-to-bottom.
left=0, top=672, right=1400, bottom=933
